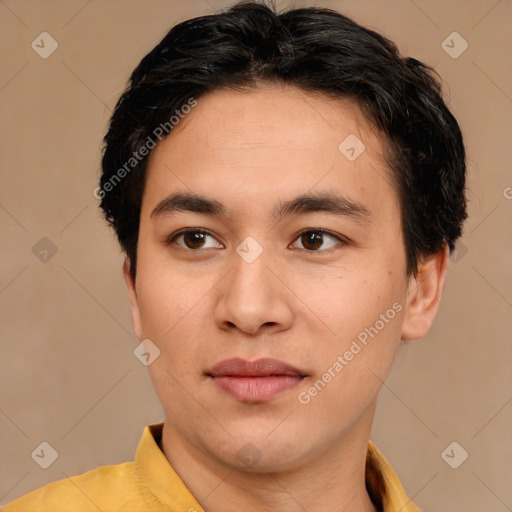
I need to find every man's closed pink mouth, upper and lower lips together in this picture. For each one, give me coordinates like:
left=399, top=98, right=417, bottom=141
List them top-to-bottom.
left=206, top=358, right=307, bottom=403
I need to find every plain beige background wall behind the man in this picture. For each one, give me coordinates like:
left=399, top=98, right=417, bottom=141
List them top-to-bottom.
left=0, top=0, right=512, bottom=512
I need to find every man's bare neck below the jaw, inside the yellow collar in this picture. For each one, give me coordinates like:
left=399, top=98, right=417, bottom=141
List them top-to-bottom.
left=162, top=407, right=377, bottom=512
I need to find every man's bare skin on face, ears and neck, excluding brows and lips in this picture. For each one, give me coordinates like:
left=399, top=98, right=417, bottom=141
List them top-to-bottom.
left=124, top=85, right=449, bottom=512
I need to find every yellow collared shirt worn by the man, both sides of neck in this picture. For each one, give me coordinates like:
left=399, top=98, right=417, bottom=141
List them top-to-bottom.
left=2, top=423, right=420, bottom=512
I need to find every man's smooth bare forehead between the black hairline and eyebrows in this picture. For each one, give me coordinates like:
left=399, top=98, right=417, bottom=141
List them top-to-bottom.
left=143, top=85, right=396, bottom=224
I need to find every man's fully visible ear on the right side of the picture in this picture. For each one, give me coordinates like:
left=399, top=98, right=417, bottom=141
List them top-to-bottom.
left=401, top=244, right=450, bottom=340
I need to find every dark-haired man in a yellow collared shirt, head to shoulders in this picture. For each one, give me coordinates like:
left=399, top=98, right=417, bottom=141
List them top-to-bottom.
left=5, top=2, right=466, bottom=512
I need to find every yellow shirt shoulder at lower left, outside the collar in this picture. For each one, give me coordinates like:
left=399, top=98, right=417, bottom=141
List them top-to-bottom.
left=2, top=462, right=137, bottom=512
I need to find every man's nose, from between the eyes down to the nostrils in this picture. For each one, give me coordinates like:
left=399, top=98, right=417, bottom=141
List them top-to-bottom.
left=215, top=250, right=293, bottom=335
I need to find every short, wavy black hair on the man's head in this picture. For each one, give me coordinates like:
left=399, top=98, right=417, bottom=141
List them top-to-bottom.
left=99, top=1, right=467, bottom=277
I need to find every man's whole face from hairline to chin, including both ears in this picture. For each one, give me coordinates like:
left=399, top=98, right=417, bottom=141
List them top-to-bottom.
left=125, top=86, right=446, bottom=471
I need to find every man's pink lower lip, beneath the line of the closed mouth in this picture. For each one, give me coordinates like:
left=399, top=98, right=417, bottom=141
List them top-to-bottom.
left=209, top=375, right=303, bottom=402
